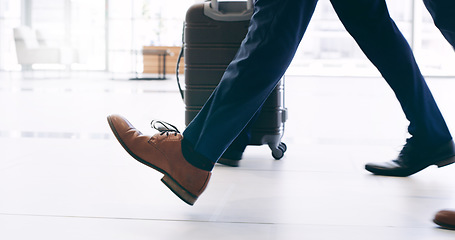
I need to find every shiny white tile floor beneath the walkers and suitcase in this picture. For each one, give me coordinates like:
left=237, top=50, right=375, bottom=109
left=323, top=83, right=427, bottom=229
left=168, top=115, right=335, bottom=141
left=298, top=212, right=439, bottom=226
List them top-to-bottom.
left=0, top=73, right=455, bottom=240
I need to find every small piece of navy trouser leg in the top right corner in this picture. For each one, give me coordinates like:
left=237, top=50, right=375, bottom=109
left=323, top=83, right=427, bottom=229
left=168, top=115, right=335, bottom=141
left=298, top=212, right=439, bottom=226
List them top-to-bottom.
left=423, top=0, right=455, bottom=48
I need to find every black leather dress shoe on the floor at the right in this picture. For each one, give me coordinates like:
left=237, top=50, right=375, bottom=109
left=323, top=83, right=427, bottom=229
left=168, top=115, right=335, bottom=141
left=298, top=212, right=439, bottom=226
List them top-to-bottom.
left=365, top=140, right=455, bottom=177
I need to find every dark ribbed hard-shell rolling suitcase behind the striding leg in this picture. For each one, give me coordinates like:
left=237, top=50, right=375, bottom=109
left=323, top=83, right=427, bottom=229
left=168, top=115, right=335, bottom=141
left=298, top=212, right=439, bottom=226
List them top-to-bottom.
left=177, top=0, right=287, bottom=159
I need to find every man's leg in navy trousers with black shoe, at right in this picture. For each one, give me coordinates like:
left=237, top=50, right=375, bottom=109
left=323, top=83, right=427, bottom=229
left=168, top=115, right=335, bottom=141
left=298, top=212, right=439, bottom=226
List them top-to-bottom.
left=331, top=0, right=455, bottom=176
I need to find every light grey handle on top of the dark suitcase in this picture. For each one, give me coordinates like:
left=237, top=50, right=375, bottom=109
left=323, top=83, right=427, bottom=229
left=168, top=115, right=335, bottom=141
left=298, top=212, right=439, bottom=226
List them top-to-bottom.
left=204, top=0, right=254, bottom=22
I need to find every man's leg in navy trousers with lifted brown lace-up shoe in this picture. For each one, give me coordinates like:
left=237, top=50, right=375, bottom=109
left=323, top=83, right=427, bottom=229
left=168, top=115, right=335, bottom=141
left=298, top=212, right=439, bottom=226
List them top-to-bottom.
left=108, top=0, right=317, bottom=205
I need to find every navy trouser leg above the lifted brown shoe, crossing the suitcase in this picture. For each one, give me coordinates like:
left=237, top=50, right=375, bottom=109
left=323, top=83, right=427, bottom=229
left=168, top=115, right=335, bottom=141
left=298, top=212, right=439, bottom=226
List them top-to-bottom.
left=183, top=0, right=317, bottom=162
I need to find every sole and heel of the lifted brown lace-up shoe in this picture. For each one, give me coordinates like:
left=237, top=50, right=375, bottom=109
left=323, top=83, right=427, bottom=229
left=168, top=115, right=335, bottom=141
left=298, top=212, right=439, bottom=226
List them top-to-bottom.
left=107, top=116, right=197, bottom=206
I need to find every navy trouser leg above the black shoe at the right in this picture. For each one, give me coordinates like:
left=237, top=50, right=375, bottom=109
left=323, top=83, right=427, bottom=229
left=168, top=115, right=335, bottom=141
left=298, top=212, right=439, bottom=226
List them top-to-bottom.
left=331, top=0, right=453, bottom=147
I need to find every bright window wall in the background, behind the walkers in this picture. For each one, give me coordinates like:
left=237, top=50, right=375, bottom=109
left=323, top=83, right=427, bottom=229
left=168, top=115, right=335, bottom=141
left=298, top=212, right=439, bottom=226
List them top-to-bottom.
left=0, top=0, right=455, bottom=76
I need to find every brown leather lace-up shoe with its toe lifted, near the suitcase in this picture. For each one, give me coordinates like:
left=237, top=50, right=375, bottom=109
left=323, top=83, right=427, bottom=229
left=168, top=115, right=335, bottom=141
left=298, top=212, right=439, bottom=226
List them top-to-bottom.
left=107, top=115, right=211, bottom=205
